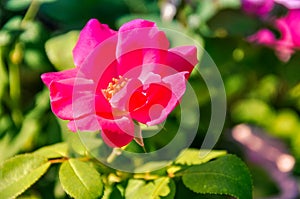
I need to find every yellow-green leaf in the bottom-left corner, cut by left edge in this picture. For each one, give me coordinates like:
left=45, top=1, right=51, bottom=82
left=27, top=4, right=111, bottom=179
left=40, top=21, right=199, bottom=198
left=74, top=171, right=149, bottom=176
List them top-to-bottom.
left=0, top=154, right=50, bottom=199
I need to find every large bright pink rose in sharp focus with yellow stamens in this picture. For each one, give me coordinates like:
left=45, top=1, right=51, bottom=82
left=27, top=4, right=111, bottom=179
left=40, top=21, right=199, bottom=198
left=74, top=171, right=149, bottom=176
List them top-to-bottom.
left=41, top=19, right=198, bottom=147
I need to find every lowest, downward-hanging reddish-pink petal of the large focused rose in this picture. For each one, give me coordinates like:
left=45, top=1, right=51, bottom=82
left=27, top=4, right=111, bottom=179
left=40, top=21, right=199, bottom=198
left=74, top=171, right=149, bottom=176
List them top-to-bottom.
left=100, top=117, right=134, bottom=147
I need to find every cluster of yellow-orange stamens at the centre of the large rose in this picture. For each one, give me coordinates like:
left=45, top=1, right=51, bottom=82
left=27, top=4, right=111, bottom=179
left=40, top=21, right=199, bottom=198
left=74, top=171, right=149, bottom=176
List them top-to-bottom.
left=102, top=75, right=128, bottom=101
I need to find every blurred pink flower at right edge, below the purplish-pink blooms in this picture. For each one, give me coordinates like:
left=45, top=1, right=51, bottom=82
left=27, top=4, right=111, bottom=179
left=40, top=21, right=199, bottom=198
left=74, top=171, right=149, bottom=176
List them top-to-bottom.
left=248, top=9, right=300, bottom=62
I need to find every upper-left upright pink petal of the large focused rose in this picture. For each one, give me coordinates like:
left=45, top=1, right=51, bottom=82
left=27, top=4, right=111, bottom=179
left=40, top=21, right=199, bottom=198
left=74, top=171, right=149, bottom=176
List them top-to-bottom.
left=73, top=19, right=116, bottom=66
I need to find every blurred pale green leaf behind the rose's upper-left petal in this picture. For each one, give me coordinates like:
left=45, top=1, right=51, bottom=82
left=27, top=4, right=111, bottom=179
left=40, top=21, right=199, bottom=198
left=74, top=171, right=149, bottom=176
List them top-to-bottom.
left=45, top=31, right=79, bottom=71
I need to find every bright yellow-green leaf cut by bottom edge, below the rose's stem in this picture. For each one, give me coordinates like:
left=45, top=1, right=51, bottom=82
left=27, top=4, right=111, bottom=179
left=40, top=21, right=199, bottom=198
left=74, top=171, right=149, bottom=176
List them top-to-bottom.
left=125, top=177, right=175, bottom=199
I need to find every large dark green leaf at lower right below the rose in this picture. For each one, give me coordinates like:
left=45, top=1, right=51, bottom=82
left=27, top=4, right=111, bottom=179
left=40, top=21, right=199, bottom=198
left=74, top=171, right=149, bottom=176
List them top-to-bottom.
left=182, top=155, right=252, bottom=199
